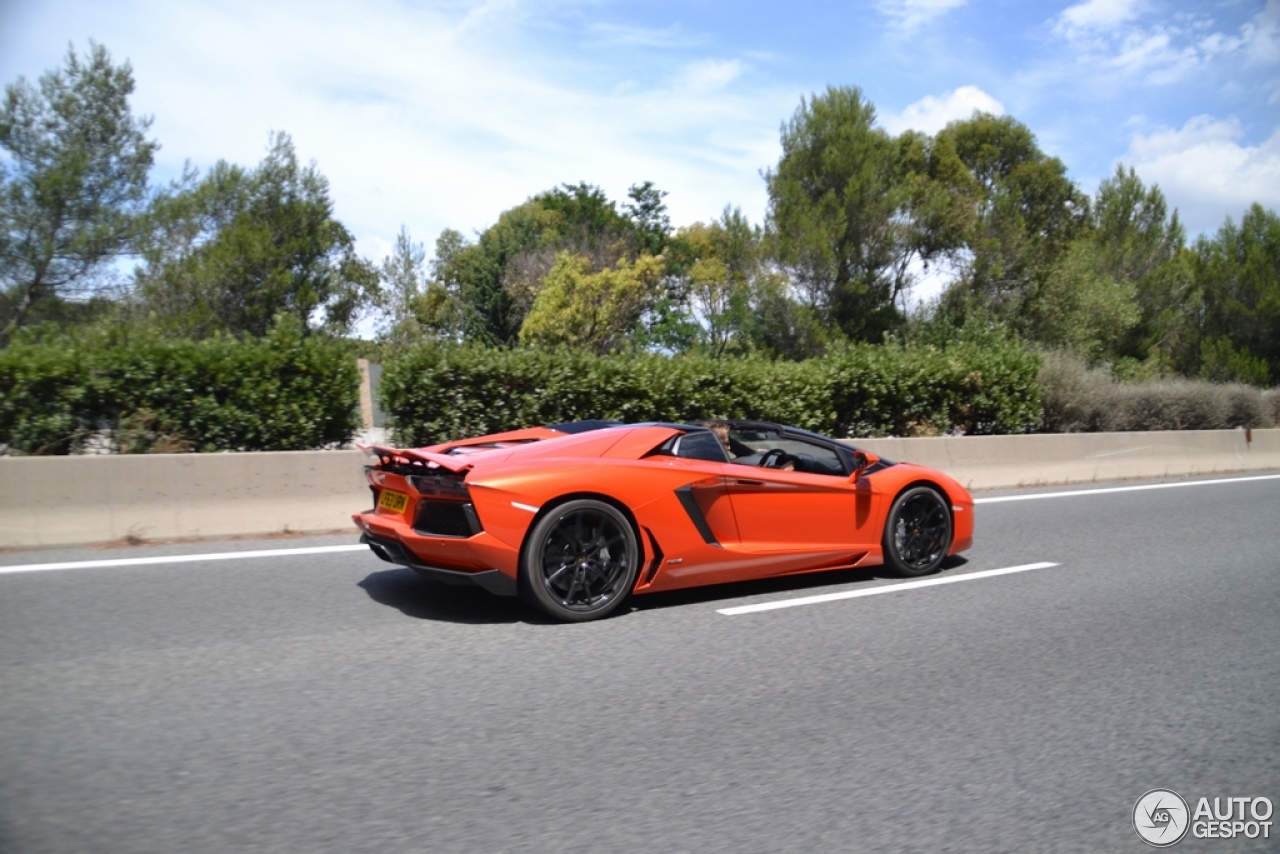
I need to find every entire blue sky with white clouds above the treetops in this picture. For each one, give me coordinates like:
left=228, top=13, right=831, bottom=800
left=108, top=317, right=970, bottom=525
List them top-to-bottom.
left=0, top=0, right=1280, bottom=280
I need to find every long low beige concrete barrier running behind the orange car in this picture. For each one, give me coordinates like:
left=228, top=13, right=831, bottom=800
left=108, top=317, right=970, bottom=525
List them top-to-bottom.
left=0, top=429, right=1280, bottom=548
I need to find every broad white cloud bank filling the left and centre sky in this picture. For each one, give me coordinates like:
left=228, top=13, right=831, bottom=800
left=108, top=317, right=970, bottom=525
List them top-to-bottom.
left=5, top=0, right=796, bottom=261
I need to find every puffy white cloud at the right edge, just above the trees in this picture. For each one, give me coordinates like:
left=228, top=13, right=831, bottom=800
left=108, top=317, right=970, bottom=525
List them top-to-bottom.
left=1121, top=115, right=1280, bottom=234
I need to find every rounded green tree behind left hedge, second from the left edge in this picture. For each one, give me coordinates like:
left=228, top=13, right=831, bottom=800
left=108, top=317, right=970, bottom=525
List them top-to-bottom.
left=137, top=133, right=378, bottom=338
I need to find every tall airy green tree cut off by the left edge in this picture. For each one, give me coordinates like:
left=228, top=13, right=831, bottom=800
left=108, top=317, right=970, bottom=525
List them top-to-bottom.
left=0, top=42, right=159, bottom=343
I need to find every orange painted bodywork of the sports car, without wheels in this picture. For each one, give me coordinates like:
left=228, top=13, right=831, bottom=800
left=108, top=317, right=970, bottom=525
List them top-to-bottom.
left=352, top=425, right=973, bottom=593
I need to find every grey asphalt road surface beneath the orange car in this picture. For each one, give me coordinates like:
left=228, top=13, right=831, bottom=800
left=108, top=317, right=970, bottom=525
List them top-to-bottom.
left=0, top=479, right=1280, bottom=854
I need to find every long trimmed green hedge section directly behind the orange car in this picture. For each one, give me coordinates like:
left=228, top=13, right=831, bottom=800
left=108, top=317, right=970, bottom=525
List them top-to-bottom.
left=379, top=343, right=1039, bottom=447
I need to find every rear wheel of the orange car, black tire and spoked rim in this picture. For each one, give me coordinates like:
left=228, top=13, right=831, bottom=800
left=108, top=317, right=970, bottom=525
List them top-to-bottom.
left=520, top=498, right=640, bottom=622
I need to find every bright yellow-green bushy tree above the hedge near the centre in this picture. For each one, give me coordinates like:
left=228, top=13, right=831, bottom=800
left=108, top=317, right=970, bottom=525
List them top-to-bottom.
left=520, top=252, right=663, bottom=355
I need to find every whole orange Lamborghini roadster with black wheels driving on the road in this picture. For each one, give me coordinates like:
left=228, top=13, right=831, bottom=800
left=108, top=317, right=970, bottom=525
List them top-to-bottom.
left=353, top=420, right=973, bottom=621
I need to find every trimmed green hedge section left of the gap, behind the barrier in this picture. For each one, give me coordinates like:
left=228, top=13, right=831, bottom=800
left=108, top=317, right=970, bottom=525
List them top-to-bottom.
left=0, top=326, right=360, bottom=453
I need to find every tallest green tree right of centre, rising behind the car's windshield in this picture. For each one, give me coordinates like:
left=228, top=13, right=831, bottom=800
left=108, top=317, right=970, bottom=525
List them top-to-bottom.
left=764, top=87, right=975, bottom=341
